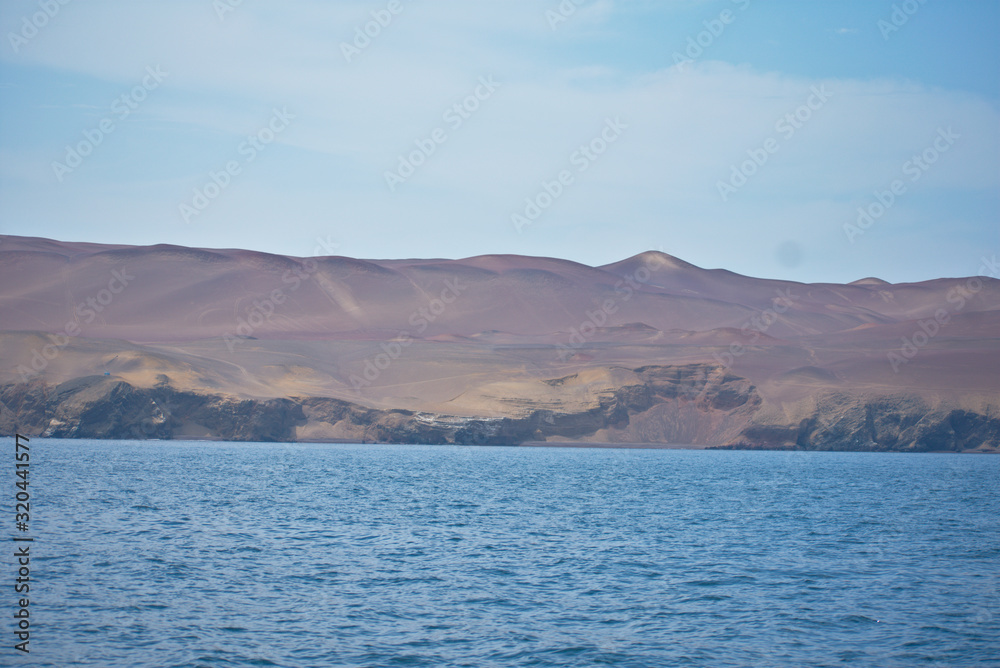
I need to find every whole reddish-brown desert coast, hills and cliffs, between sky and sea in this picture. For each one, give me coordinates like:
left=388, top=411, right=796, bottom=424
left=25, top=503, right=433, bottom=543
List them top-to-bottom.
left=0, top=236, right=1000, bottom=449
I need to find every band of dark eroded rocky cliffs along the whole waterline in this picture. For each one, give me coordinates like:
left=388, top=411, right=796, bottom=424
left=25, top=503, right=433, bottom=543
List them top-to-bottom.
left=0, top=364, right=1000, bottom=451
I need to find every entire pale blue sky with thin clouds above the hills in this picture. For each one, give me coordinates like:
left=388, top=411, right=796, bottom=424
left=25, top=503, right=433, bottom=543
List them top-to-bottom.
left=0, top=0, right=1000, bottom=282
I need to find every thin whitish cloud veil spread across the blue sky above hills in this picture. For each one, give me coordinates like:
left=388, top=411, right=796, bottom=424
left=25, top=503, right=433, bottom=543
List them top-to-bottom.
left=0, top=0, right=1000, bottom=278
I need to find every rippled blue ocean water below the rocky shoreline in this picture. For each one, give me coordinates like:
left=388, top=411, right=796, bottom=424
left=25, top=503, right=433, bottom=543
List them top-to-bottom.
left=0, top=439, right=1000, bottom=668
